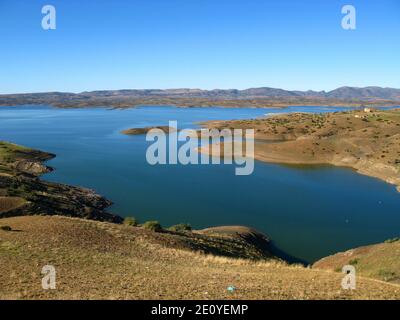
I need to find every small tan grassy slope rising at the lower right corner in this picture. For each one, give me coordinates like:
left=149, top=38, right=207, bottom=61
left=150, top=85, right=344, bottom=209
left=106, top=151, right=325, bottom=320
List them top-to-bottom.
left=313, top=239, right=400, bottom=284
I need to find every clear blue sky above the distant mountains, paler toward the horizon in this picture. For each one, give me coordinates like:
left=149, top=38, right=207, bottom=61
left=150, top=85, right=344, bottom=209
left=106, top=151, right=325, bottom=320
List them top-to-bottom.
left=0, top=0, right=400, bottom=93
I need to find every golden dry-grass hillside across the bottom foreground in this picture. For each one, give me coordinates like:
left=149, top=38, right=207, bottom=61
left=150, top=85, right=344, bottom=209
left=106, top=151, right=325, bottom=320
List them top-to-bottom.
left=0, top=216, right=400, bottom=299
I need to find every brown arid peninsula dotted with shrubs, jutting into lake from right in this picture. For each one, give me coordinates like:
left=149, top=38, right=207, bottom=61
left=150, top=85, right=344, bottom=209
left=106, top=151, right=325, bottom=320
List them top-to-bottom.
left=203, top=109, right=400, bottom=190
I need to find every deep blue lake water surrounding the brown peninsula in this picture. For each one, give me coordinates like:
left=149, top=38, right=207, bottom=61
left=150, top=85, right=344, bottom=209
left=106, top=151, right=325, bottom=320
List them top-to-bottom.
left=0, top=106, right=400, bottom=262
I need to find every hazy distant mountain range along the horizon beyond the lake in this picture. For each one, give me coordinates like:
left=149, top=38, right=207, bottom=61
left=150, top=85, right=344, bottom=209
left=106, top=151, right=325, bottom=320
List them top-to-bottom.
left=0, top=87, right=400, bottom=107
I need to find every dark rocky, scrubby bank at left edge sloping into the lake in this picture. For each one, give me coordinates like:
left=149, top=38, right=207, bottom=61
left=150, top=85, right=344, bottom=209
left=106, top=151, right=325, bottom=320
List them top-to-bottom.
left=0, top=144, right=123, bottom=223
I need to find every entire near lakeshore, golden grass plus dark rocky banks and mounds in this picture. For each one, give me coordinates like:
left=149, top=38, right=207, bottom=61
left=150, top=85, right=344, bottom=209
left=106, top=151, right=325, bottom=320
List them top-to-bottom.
left=0, top=142, right=400, bottom=299
